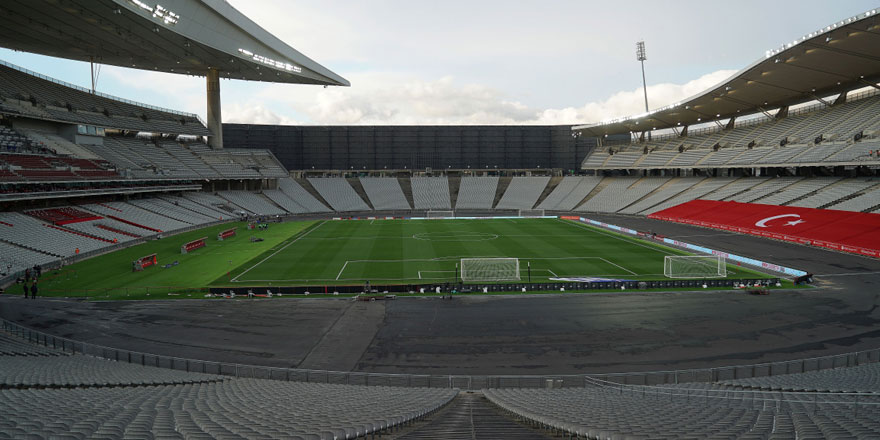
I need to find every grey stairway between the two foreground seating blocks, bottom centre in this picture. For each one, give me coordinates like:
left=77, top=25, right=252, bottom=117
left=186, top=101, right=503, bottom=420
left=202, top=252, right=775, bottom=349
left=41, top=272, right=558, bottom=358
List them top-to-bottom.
left=394, top=392, right=551, bottom=440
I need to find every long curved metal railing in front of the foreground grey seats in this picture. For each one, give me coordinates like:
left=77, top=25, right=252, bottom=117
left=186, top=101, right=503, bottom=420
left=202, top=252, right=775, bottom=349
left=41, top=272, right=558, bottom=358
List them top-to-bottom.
left=0, top=319, right=880, bottom=390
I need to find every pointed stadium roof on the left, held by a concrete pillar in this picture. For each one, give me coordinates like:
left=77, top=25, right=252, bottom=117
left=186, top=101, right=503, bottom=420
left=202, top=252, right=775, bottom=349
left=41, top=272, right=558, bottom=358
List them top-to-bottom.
left=0, top=0, right=350, bottom=86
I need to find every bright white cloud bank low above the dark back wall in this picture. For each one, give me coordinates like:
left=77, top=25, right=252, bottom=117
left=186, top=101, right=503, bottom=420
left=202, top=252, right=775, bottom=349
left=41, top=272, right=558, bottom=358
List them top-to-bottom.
left=244, top=70, right=734, bottom=125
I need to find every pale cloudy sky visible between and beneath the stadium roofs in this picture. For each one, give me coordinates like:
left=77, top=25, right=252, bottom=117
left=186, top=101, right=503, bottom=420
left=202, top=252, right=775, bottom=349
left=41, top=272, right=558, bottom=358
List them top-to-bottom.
left=0, top=0, right=877, bottom=125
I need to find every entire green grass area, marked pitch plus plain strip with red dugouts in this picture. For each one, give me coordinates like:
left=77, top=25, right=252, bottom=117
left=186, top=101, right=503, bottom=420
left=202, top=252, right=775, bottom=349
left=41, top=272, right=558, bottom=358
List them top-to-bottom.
left=41, top=219, right=768, bottom=299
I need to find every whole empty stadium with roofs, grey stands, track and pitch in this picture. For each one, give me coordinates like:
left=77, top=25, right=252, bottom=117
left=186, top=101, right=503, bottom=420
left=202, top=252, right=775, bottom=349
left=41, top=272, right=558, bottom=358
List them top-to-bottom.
left=0, top=0, right=880, bottom=440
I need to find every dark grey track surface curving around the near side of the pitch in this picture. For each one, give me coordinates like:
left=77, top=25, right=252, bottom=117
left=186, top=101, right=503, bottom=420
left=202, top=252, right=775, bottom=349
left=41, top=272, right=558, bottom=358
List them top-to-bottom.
left=0, top=215, right=880, bottom=374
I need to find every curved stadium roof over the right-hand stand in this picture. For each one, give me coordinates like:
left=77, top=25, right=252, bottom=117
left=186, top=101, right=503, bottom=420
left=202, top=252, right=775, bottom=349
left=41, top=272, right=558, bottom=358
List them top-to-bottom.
left=572, top=10, right=880, bottom=136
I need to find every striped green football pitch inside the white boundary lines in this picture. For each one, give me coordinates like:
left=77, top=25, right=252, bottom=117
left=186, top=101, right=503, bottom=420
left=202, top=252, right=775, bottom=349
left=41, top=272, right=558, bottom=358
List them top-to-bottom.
left=229, top=218, right=766, bottom=286
